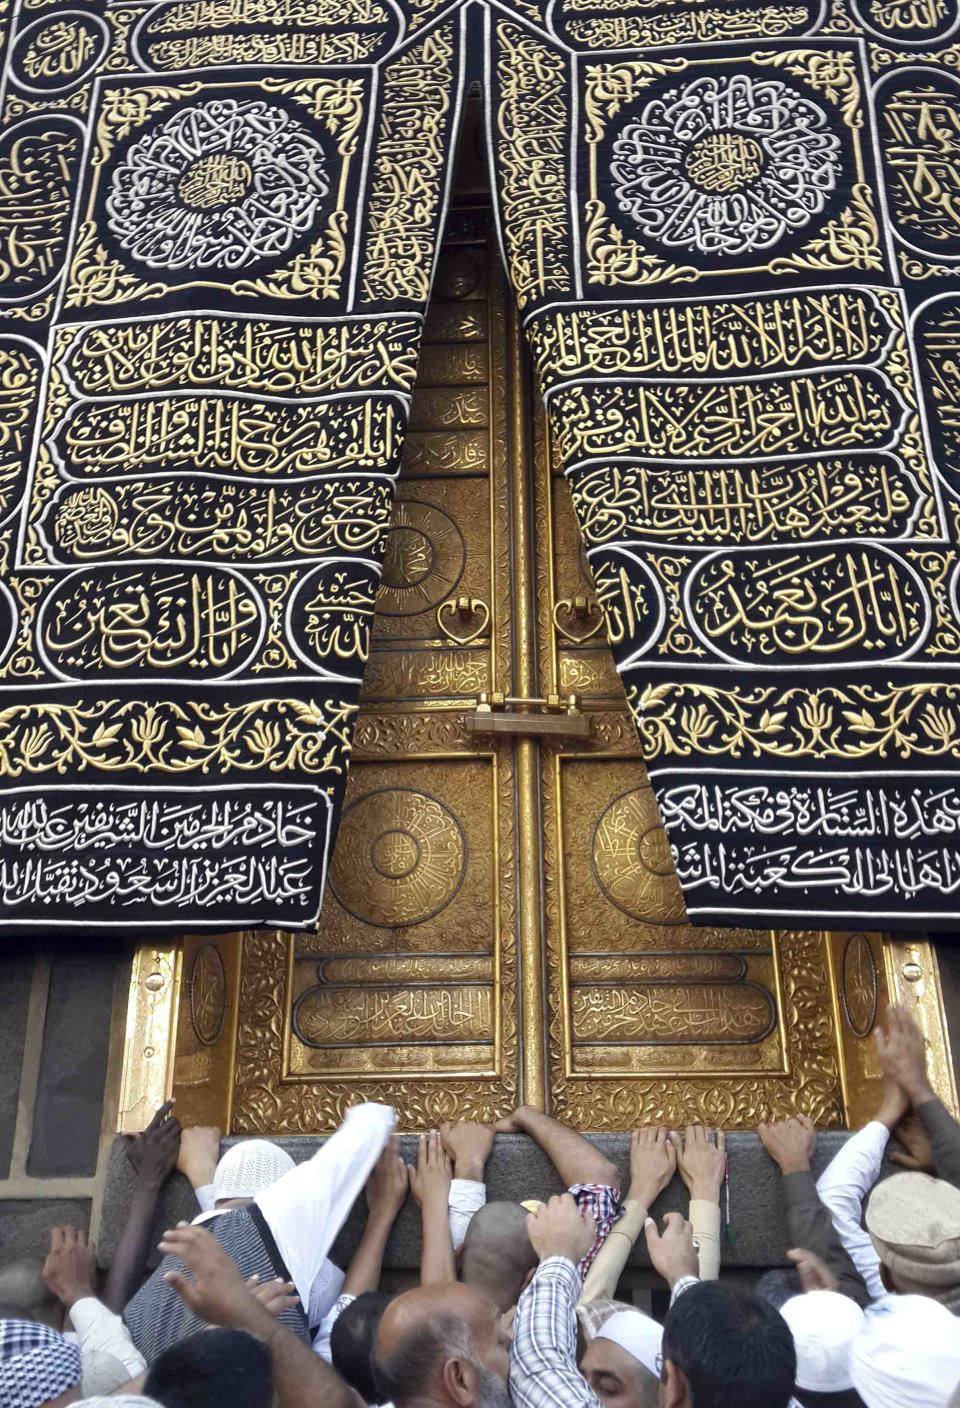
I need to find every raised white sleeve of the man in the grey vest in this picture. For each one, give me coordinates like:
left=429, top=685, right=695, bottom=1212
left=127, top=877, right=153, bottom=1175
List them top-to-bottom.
left=255, top=1104, right=394, bottom=1311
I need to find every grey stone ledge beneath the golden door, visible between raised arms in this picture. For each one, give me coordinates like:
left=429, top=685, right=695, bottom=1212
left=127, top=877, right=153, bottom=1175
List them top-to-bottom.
left=100, top=1131, right=847, bottom=1271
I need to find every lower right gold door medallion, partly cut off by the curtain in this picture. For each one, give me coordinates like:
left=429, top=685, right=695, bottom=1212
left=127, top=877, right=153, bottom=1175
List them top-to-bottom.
left=593, top=783, right=687, bottom=924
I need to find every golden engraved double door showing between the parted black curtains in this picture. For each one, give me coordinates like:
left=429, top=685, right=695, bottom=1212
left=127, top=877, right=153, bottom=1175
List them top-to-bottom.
left=121, top=104, right=954, bottom=1133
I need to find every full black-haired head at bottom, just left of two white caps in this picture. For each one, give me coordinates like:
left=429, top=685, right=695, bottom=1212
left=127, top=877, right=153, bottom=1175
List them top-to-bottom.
left=660, top=1281, right=797, bottom=1408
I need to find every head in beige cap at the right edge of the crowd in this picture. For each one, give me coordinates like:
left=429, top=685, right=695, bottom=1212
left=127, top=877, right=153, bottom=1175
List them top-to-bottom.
left=864, top=1173, right=960, bottom=1300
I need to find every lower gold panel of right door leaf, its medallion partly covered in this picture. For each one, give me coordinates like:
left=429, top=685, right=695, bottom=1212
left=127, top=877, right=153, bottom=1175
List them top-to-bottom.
left=555, top=756, right=785, bottom=1074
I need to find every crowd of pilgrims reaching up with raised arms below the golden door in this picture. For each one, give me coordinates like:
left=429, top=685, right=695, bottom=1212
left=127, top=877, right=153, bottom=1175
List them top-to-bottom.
left=0, top=1007, right=960, bottom=1408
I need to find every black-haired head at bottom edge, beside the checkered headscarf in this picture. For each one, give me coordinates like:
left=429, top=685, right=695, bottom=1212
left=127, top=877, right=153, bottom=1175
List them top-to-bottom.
left=144, top=1329, right=273, bottom=1408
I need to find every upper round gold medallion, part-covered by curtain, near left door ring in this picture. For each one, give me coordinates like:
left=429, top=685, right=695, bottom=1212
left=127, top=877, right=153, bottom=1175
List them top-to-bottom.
left=377, top=500, right=467, bottom=615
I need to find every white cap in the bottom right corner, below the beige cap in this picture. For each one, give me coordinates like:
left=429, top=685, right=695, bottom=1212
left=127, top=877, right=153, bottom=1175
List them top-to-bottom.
left=850, top=1295, right=960, bottom=1408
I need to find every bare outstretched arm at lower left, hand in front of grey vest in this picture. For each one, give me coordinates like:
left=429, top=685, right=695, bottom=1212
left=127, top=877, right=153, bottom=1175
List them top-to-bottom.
left=160, top=1226, right=362, bottom=1408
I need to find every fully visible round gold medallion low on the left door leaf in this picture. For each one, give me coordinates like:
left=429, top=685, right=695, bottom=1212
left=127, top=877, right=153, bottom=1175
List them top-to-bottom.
left=329, top=787, right=466, bottom=929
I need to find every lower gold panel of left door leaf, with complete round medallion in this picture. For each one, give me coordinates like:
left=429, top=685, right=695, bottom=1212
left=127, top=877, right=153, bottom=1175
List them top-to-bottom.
left=287, top=756, right=503, bottom=1080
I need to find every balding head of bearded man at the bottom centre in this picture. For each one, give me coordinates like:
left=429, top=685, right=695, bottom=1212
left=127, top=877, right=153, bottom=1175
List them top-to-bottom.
left=373, top=1283, right=510, bottom=1408
